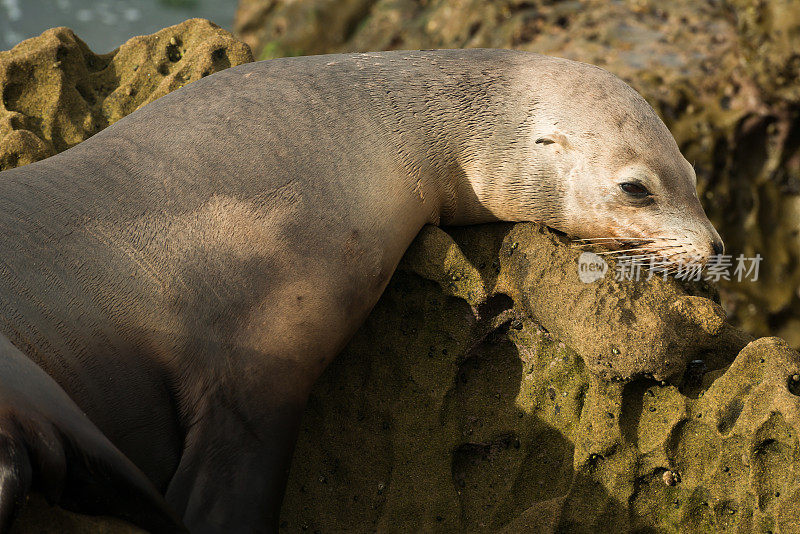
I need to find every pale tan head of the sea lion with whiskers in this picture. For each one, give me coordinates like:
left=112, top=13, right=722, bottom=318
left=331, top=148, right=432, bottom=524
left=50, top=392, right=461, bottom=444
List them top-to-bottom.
left=512, top=59, right=723, bottom=263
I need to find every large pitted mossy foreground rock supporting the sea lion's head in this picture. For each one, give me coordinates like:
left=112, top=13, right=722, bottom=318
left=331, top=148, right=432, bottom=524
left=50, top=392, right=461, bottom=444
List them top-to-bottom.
left=282, top=224, right=800, bottom=533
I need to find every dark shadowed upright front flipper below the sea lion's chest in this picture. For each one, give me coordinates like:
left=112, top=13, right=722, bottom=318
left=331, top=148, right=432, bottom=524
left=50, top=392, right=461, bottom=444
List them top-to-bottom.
left=166, top=395, right=305, bottom=534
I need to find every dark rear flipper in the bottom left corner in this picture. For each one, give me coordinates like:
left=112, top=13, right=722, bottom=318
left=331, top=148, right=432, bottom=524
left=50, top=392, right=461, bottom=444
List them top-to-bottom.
left=0, top=335, right=186, bottom=532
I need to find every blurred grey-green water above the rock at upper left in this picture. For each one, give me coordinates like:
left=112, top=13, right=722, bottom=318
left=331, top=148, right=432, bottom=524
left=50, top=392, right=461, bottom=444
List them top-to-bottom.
left=0, top=0, right=238, bottom=53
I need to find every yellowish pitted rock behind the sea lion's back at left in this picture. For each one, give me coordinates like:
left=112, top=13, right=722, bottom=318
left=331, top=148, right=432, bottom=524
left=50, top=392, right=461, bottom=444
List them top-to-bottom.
left=0, top=19, right=253, bottom=171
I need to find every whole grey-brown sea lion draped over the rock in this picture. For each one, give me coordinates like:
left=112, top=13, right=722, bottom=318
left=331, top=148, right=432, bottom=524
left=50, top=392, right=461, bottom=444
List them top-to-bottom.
left=0, top=50, right=722, bottom=532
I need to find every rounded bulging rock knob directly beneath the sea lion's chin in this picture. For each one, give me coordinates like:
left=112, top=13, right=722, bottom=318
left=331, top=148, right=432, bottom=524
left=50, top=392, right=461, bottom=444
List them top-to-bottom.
left=499, top=224, right=749, bottom=386
